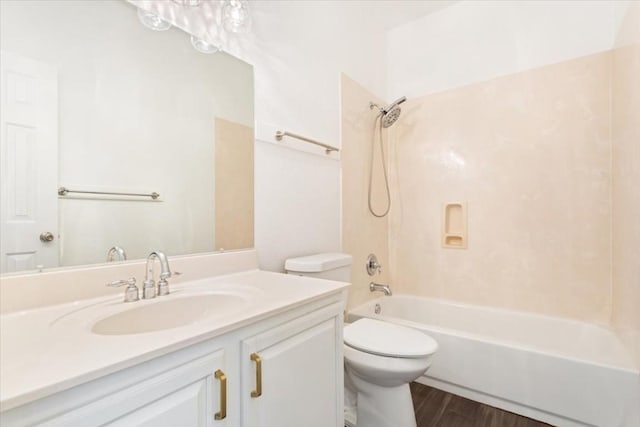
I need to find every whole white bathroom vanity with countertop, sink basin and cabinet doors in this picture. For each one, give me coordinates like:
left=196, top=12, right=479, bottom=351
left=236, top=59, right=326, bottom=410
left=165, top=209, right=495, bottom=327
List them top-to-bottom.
left=0, top=250, right=348, bottom=427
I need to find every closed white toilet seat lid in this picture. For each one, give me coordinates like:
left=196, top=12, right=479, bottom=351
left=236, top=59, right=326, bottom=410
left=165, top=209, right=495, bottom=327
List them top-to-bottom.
left=344, top=318, right=438, bottom=359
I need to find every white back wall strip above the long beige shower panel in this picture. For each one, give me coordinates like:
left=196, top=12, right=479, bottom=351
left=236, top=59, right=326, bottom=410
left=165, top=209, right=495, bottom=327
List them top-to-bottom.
left=387, top=0, right=625, bottom=98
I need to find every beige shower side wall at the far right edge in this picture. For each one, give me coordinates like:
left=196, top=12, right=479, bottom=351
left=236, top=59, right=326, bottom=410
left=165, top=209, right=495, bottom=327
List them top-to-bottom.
left=612, top=4, right=640, bottom=366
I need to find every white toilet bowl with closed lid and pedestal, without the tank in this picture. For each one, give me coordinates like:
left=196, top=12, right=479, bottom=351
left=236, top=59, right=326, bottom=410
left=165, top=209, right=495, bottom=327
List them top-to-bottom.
left=344, top=319, right=438, bottom=427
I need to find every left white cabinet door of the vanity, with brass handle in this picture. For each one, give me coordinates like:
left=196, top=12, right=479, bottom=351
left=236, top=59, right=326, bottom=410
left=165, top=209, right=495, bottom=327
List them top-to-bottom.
left=44, top=350, right=227, bottom=427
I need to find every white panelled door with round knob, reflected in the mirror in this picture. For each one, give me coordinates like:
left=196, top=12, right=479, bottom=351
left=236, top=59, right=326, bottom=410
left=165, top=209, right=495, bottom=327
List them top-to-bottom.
left=0, top=51, right=58, bottom=273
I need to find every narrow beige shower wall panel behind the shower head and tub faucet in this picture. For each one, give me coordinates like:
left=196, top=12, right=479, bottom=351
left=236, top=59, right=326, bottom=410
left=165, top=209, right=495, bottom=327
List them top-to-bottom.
left=340, top=75, right=389, bottom=308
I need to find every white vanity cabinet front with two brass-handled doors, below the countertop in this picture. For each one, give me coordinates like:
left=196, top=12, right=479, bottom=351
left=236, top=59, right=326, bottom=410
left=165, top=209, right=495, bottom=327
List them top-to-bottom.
left=0, top=293, right=343, bottom=427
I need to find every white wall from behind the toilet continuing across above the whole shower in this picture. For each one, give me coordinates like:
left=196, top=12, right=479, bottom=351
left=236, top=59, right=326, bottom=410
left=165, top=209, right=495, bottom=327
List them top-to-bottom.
left=221, top=1, right=636, bottom=270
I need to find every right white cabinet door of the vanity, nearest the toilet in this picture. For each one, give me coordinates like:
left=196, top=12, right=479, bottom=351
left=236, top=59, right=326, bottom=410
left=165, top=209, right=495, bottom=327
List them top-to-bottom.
left=241, top=306, right=343, bottom=427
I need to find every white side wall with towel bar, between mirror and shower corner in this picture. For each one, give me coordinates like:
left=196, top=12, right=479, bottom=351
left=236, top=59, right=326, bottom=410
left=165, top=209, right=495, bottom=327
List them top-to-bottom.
left=233, top=1, right=385, bottom=270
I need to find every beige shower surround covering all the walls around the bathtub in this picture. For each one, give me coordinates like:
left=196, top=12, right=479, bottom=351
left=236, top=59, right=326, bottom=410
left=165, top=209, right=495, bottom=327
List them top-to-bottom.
left=342, top=3, right=640, bottom=366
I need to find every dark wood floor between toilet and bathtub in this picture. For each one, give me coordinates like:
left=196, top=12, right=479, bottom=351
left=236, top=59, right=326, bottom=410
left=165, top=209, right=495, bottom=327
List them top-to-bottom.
left=411, top=383, right=549, bottom=427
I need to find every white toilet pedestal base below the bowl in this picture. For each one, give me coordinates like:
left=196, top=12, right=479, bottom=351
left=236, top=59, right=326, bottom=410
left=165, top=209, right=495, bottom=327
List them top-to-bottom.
left=350, top=375, right=416, bottom=427
